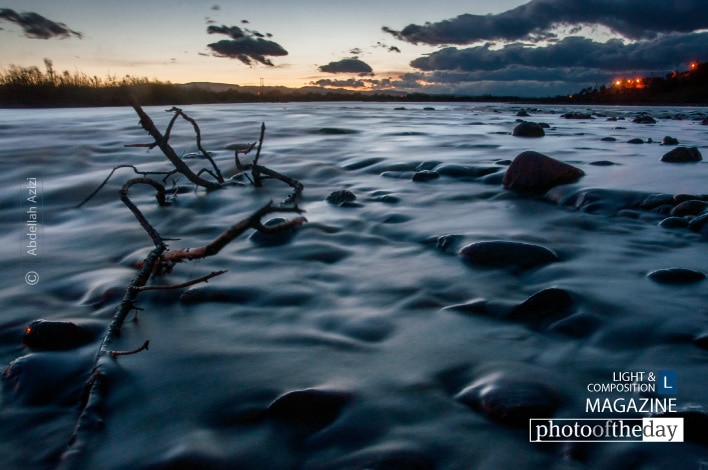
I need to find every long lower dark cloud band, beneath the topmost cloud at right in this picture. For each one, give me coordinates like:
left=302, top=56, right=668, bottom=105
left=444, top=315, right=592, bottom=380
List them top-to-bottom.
left=411, top=33, right=708, bottom=73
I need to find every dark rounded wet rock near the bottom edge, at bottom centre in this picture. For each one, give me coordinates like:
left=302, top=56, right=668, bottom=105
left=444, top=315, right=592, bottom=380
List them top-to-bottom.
left=266, top=388, right=351, bottom=429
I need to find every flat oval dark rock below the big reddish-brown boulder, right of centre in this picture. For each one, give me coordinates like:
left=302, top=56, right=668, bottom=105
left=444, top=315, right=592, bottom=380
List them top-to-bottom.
left=460, top=240, right=559, bottom=268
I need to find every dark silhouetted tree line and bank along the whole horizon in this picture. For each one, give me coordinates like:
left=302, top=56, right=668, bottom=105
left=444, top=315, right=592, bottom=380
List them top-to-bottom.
left=0, top=59, right=708, bottom=107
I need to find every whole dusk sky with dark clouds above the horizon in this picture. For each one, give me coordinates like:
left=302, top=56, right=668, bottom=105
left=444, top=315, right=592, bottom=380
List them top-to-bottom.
left=0, top=0, right=708, bottom=97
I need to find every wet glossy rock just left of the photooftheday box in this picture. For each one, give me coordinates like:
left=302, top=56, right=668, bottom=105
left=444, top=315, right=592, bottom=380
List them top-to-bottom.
left=455, top=375, right=559, bottom=428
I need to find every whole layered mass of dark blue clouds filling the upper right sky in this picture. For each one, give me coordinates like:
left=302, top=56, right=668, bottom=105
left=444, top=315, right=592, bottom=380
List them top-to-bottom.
left=383, top=0, right=708, bottom=96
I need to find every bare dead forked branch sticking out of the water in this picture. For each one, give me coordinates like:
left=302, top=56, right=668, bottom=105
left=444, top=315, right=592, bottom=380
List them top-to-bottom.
left=62, top=97, right=306, bottom=468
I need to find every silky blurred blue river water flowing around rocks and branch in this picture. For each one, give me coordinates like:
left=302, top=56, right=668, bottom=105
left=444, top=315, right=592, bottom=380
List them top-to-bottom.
left=0, top=103, right=708, bottom=469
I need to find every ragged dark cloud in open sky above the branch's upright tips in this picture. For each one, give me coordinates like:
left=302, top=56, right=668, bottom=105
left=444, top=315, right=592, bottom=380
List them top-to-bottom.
left=207, top=25, right=288, bottom=66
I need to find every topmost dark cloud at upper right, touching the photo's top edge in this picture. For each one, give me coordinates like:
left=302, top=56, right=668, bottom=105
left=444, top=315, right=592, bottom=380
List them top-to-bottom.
left=383, top=0, right=708, bottom=45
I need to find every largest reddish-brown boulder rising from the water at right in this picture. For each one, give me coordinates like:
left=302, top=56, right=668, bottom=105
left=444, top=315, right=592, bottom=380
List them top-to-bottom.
left=503, top=151, right=585, bottom=193
